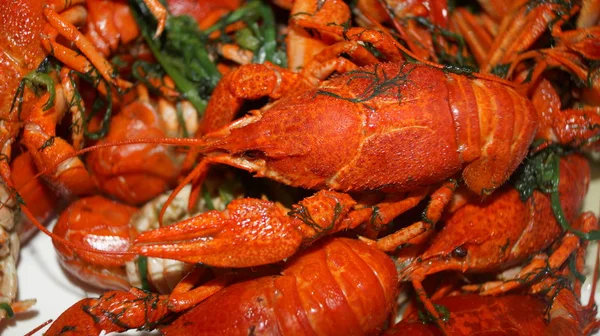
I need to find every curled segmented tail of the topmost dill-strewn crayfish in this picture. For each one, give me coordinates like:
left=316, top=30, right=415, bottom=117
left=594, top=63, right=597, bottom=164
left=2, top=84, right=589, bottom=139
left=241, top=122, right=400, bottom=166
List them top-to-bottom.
left=448, top=75, right=537, bottom=194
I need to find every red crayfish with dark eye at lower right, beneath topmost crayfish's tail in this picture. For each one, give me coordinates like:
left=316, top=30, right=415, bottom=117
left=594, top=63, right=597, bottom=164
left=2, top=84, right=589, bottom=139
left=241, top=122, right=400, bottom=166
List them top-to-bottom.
left=396, top=154, right=598, bottom=328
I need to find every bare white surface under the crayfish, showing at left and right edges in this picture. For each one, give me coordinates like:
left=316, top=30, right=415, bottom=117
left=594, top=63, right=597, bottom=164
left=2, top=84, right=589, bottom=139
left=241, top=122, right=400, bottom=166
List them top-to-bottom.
left=0, top=163, right=600, bottom=335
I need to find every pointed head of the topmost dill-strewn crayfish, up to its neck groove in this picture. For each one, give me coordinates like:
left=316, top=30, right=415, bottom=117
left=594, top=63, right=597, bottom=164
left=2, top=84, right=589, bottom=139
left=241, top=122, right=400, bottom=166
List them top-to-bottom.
left=200, top=92, right=363, bottom=189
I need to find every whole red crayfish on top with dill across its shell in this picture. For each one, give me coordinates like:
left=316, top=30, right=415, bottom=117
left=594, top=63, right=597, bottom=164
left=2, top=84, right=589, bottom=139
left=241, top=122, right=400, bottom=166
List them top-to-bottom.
left=132, top=63, right=537, bottom=267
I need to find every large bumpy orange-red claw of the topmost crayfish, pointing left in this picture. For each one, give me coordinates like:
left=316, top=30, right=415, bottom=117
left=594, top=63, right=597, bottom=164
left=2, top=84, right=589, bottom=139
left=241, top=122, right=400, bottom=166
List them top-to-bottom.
left=131, top=198, right=302, bottom=267
